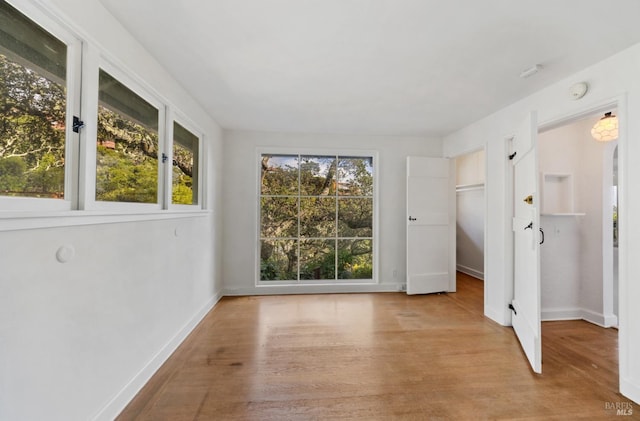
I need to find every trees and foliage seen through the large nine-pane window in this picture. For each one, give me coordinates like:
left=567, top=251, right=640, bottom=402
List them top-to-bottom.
left=260, top=154, right=373, bottom=281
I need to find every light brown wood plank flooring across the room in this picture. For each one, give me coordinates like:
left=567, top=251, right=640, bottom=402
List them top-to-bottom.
left=118, top=274, right=640, bottom=420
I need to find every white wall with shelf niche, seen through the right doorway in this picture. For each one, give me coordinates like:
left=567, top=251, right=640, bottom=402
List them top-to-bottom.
left=539, top=115, right=613, bottom=325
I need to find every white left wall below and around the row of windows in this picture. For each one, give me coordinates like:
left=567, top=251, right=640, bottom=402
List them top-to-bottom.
left=0, top=0, right=222, bottom=420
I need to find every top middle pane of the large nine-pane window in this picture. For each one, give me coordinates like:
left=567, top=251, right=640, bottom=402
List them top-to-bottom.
left=300, top=155, right=336, bottom=196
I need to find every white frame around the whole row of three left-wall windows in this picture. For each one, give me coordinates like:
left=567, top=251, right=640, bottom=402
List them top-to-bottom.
left=0, top=0, right=210, bottom=232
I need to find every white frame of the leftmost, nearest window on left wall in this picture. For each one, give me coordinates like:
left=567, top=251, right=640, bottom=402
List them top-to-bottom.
left=0, top=1, right=82, bottom=210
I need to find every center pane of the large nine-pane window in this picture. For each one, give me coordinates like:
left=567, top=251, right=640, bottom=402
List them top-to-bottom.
left=300, top=197, right=336, bottom=237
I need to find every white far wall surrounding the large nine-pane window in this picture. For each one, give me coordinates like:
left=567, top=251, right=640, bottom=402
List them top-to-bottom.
left=223, top=131, right=442, bottom=294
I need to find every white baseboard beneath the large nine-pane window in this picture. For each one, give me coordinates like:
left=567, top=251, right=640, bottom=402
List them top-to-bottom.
left=224, top=283, right=402, bottom=296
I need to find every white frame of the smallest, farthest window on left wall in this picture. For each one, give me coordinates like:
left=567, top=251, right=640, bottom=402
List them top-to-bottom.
left=164, top=108, right=205, bottom=211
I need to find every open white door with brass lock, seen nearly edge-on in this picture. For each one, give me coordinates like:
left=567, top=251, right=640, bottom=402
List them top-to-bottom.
left=511, top=113, right=542, bottom=373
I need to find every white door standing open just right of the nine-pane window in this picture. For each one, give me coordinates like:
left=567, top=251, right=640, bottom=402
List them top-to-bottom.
left=406, top=156, right=455, bottom=294
